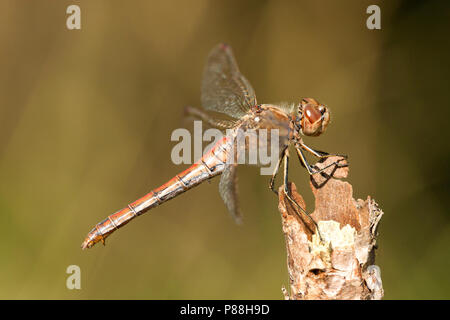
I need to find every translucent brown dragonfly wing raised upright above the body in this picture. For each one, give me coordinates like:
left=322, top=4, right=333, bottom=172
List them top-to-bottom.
left=201, top=44, right=257, bottom=119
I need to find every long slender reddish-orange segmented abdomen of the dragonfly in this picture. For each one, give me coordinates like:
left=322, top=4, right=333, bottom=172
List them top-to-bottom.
left=82, top=137, right=229, bottom=249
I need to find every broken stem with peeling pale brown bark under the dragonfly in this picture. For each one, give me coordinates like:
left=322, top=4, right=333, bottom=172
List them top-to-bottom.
left=279, top=158, right=383, bottom=300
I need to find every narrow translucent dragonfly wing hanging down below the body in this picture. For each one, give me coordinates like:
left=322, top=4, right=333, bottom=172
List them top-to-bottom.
left=219, top=164, right=242, bottom=224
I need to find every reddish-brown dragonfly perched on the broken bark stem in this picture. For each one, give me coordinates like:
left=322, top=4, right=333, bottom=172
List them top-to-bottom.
left=82, top=43, right=347, bottom=249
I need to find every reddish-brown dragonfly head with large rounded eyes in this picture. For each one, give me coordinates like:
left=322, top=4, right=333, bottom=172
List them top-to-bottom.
left=296, top=98, right=330, bottom=137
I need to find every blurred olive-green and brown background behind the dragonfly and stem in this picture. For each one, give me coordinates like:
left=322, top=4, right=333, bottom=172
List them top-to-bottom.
left=0, top=0, right=450, bottom=299
